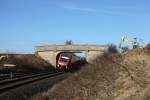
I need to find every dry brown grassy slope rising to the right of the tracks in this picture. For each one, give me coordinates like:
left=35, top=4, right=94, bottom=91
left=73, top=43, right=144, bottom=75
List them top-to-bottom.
left=35, top=47, right=150, bottom=100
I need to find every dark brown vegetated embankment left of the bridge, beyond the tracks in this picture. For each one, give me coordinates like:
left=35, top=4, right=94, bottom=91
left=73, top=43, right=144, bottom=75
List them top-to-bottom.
left=0, top=54, right=53, bottom=72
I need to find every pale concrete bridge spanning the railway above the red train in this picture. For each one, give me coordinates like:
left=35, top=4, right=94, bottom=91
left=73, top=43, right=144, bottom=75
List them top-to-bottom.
left=35, top=45, right=109, bottom=66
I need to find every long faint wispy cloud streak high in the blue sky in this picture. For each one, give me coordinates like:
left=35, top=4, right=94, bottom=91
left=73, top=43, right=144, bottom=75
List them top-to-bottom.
left=60, top=4, right=149, bottom=15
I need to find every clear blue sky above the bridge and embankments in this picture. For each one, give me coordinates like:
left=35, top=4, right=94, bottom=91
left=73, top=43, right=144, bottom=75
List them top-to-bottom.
left=0, top=0, right=150, bottom=53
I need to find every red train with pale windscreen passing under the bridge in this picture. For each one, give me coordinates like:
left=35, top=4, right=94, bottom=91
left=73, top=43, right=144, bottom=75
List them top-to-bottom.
left=56, top=52, right=80, bottom=69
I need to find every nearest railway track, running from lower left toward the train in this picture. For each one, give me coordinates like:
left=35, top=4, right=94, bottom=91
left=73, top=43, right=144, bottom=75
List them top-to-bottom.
left=0, top=72, right=63, bottom=94
